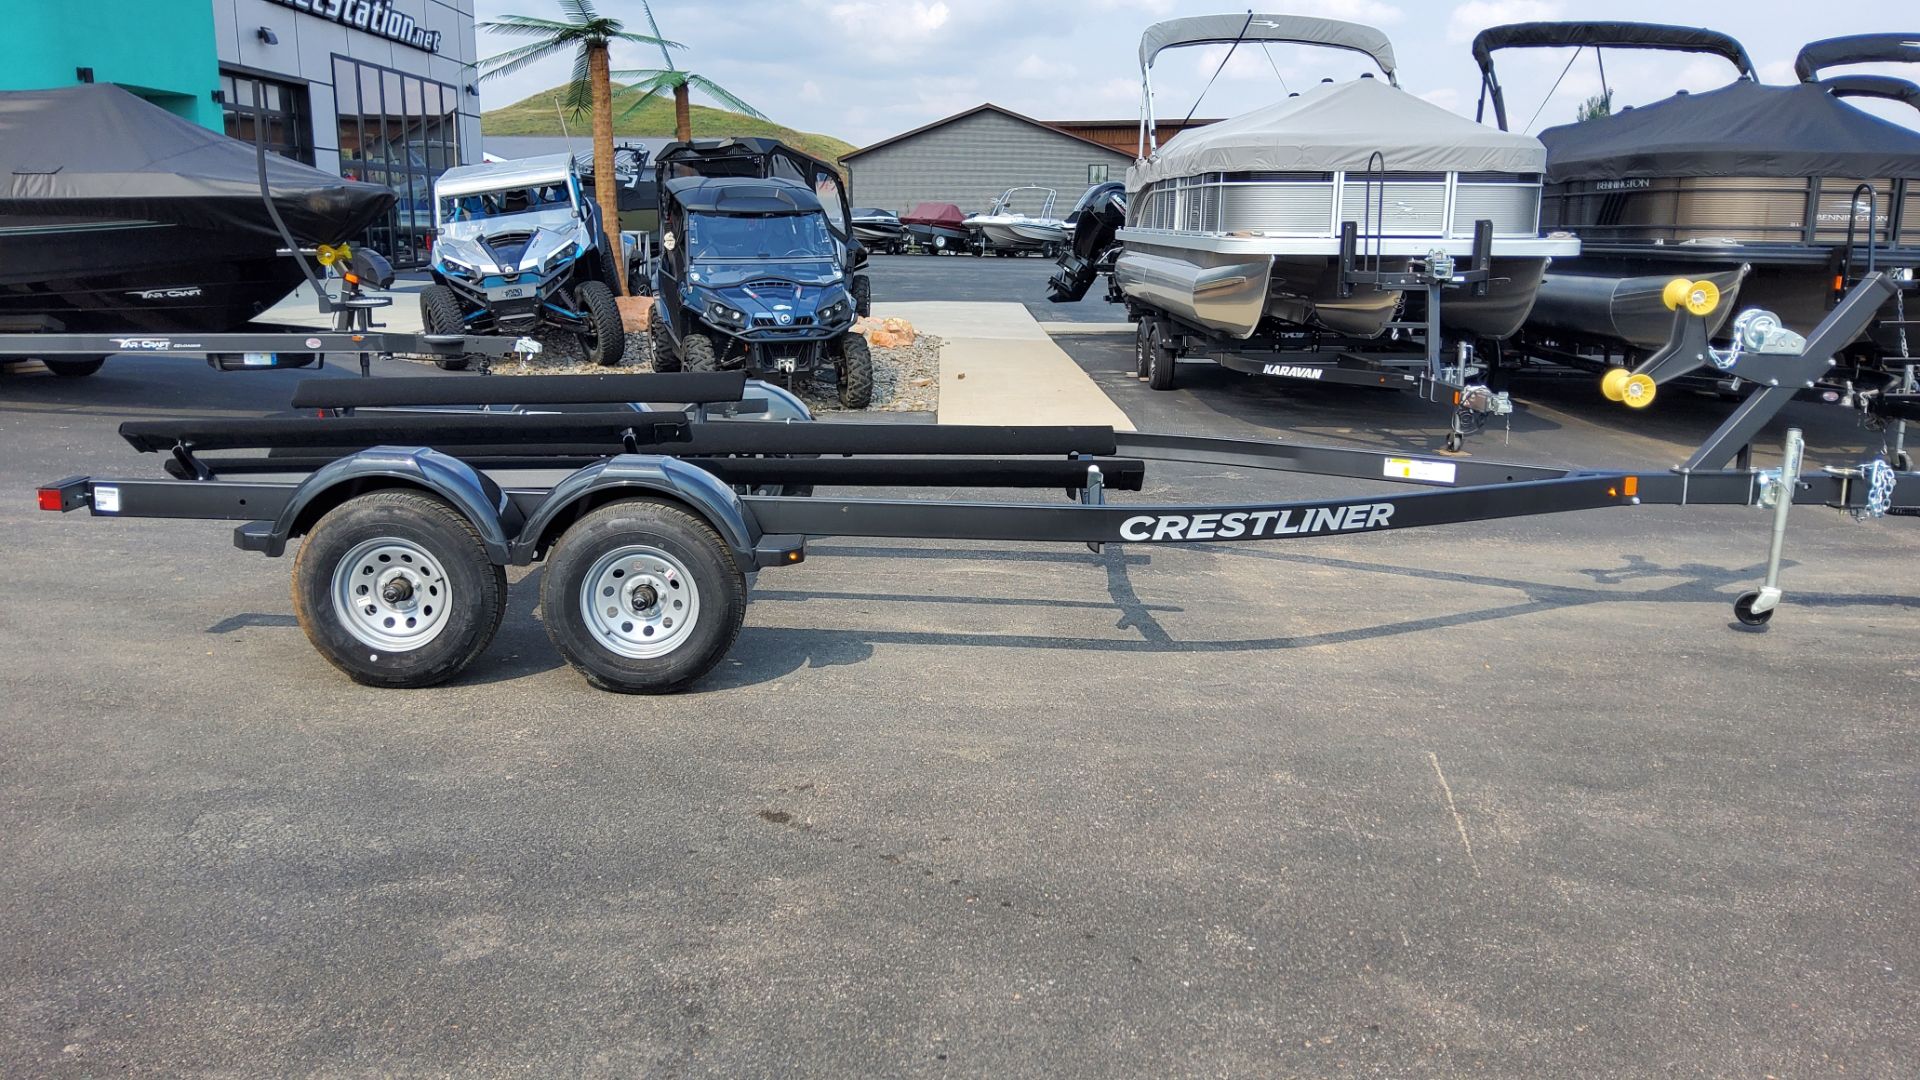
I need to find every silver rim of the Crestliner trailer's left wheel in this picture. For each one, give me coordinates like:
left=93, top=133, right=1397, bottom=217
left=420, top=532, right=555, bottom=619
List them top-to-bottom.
left=332, top=536, right=453, bottom=653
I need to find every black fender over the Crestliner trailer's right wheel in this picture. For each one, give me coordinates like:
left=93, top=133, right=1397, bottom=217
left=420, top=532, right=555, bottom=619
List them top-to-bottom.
left=513, top=454, right=760, bottom=571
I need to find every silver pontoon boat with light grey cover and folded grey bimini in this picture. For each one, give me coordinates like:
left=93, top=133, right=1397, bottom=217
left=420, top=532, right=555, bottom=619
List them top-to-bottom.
left=1114, top=13, right=1578, bottom=340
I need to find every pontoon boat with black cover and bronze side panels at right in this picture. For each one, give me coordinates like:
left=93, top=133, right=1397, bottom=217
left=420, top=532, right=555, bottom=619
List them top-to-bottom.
left=1473, top=23, right=1920, bottom=357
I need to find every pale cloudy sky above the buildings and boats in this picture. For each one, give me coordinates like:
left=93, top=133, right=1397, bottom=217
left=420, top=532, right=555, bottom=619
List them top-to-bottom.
left=474, top=0, right=1920, bottom=146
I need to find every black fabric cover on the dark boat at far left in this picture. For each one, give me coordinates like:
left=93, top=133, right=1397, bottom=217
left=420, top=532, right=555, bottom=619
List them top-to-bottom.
left=0, top=83, right=394, bottom=244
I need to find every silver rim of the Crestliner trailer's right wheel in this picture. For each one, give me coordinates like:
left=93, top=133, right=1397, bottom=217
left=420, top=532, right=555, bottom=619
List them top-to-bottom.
left=580, top=544, right=701, bottom=659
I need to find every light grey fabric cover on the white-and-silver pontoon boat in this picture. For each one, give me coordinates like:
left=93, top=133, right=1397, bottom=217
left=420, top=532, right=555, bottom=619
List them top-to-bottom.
left=1127, top=79, right=1548, bottom=192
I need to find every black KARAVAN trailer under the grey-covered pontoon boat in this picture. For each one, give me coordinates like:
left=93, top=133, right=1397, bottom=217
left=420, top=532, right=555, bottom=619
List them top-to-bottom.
left=1108, top=216, right=1513, bottom=452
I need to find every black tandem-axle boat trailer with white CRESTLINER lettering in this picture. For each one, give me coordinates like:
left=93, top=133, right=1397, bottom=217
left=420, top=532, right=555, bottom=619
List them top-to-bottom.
left=38, top=342, right=1920, bottom=694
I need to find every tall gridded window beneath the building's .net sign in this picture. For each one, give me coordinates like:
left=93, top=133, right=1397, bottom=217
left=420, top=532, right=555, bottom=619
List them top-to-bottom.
left=334, top=56, right=461, bottom=267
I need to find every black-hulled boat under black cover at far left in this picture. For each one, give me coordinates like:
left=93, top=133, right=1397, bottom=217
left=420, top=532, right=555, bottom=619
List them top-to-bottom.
left=0, top=83, right=394, bottom=332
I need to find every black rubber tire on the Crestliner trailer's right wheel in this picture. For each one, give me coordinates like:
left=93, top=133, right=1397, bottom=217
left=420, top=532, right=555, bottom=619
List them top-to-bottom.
left=540, top=500, right=747, bottom=694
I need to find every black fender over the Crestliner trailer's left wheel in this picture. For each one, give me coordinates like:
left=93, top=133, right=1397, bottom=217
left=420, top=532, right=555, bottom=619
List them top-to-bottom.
left=247, top=446, right=522, bottom=565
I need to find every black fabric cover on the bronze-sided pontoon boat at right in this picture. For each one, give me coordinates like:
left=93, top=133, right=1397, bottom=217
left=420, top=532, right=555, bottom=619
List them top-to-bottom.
left=1540, top=81, right=1920, bottom=184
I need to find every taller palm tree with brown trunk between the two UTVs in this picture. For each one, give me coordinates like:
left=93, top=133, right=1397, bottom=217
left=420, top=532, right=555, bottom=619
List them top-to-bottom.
left=480, top=0, right=685, bottom=296
